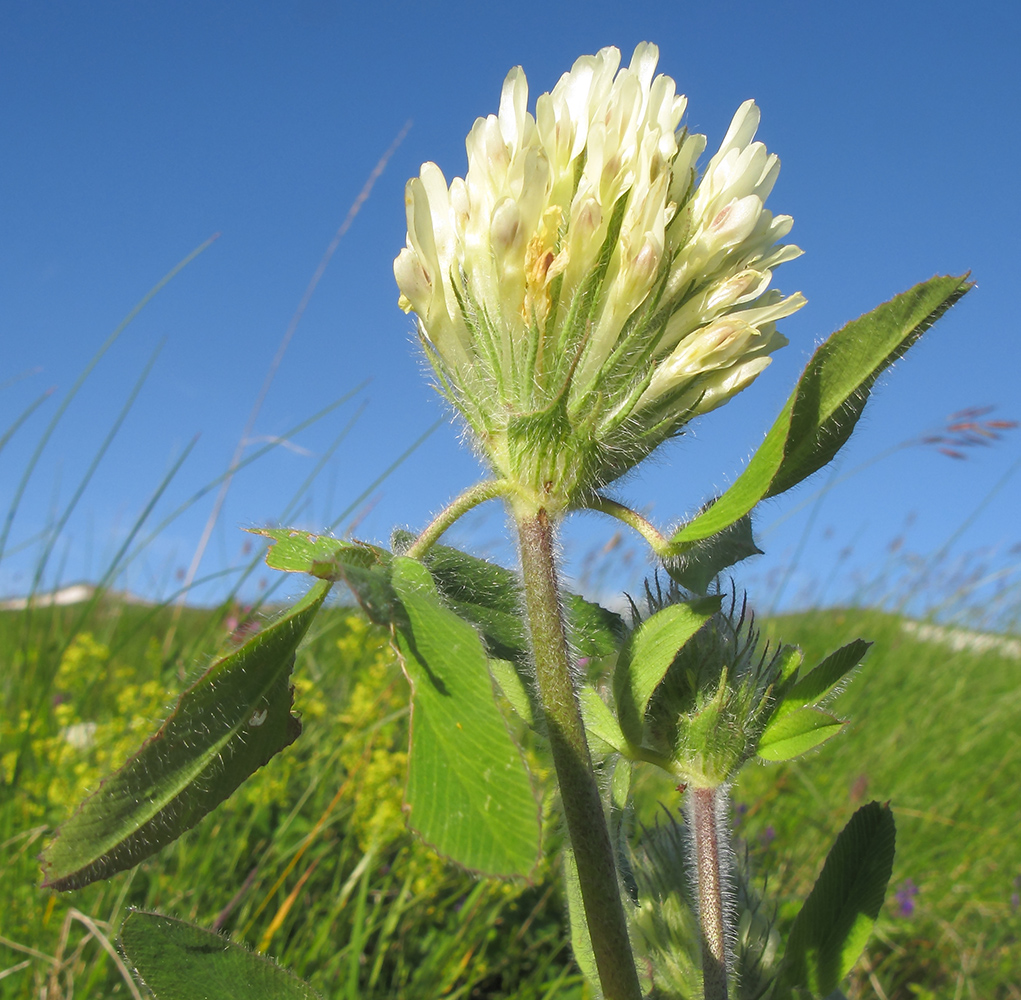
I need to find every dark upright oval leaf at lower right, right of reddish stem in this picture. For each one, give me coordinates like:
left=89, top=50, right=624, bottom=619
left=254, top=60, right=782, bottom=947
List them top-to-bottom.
left=781, top=802, right=896, bottom=996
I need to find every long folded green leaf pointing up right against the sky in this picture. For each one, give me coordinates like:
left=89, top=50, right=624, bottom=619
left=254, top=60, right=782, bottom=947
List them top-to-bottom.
left=671, top=276, right=972, bottom=552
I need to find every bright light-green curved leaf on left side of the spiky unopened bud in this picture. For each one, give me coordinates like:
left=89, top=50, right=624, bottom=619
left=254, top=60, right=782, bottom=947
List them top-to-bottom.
left=614, top=596, right=723, bottom=745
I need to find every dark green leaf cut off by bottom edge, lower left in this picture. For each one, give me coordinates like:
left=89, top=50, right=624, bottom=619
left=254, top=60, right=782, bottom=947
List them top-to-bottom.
left=120, top=910, right=319, bottom=1000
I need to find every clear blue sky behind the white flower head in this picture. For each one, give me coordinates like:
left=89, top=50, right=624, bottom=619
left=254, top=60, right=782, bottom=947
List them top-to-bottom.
left=0, top=0, right=1021, bottom=621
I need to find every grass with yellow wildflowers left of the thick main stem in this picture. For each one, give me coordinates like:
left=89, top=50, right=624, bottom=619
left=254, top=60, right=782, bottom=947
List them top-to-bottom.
left=0, top=603, right=584, bottom=1000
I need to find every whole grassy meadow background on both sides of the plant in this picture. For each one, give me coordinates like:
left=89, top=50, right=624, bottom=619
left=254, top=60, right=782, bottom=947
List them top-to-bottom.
left=0, top=600, right=1021, bottom=1000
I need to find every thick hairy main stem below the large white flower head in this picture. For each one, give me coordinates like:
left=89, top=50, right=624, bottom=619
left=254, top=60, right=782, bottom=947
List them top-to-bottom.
left=518, top=508, right=641, bottom=1000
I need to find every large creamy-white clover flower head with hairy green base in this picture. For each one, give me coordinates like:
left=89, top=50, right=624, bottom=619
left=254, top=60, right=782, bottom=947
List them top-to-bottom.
left=394, top=43, right=805, bottom=509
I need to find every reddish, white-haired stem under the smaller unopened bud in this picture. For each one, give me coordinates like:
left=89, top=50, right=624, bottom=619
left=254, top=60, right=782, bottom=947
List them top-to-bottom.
left=688, top=789, right=727, bottom=1000
